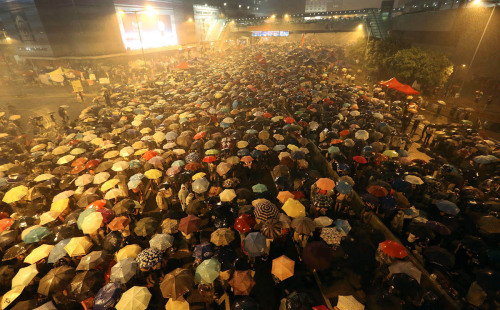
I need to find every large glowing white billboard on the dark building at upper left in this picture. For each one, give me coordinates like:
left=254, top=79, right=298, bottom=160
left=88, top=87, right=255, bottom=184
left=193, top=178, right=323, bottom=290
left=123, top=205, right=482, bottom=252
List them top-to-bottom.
left=116, top=6, right=178, bottom=50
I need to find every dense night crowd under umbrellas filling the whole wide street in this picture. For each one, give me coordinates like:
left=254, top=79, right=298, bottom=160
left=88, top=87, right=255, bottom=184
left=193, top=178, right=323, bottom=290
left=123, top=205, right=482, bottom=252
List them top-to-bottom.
left=0, top=44, right=500, bottom=310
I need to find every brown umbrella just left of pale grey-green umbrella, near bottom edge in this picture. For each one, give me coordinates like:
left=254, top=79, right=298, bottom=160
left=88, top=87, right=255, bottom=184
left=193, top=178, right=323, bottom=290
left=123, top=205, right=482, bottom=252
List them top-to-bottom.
left=160, top=268, right=194, bottom=299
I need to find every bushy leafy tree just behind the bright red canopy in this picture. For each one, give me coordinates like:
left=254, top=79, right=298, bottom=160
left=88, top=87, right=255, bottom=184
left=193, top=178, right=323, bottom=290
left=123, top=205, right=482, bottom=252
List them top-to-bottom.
left=385, top=47, right=453, bottom=92
